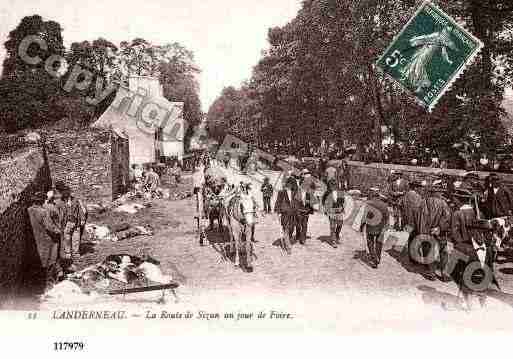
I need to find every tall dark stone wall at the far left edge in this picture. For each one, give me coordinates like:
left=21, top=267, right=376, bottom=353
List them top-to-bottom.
left=0, top=146, right=51, bottom=308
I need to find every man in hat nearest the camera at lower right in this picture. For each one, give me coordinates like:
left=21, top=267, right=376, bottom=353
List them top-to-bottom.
left=451, top=189, right=497, bottom=309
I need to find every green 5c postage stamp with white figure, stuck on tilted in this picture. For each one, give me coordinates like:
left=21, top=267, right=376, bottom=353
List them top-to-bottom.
left=376, top=1, right=483, bottom=112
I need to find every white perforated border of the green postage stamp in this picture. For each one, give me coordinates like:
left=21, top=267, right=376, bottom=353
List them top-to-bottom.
left=375, top=0, right=484, bottom=112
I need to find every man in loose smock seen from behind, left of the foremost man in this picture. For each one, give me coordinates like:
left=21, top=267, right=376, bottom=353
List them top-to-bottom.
left=417, top=179, right=451, bottom=282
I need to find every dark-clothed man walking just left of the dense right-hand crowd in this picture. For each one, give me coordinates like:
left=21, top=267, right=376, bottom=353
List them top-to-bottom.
left=362, top=188, right=389, bottom=269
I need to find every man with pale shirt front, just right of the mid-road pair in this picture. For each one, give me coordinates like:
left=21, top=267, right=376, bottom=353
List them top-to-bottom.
left=323, top=179, right=345, bottom=248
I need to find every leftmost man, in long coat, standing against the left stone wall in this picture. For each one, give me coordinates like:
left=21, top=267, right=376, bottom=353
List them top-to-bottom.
left=27, top=193, right=61, bottom=285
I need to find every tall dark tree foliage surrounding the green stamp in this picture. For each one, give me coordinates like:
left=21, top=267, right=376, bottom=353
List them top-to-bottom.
left=208, top=0, right=513, bottom=163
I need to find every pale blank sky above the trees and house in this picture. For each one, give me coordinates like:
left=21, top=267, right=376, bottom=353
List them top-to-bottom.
left=0, top=0, right=301, bottom=112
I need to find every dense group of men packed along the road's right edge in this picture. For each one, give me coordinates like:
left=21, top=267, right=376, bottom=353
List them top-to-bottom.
left=380, top=171, right=513, bottom=310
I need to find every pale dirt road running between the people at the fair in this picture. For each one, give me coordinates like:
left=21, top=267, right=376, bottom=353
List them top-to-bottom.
left=42, top=166, right=513, bottom=332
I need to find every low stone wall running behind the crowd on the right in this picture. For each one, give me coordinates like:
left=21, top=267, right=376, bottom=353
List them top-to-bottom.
left=348, top=161, right=513, bottom=190
